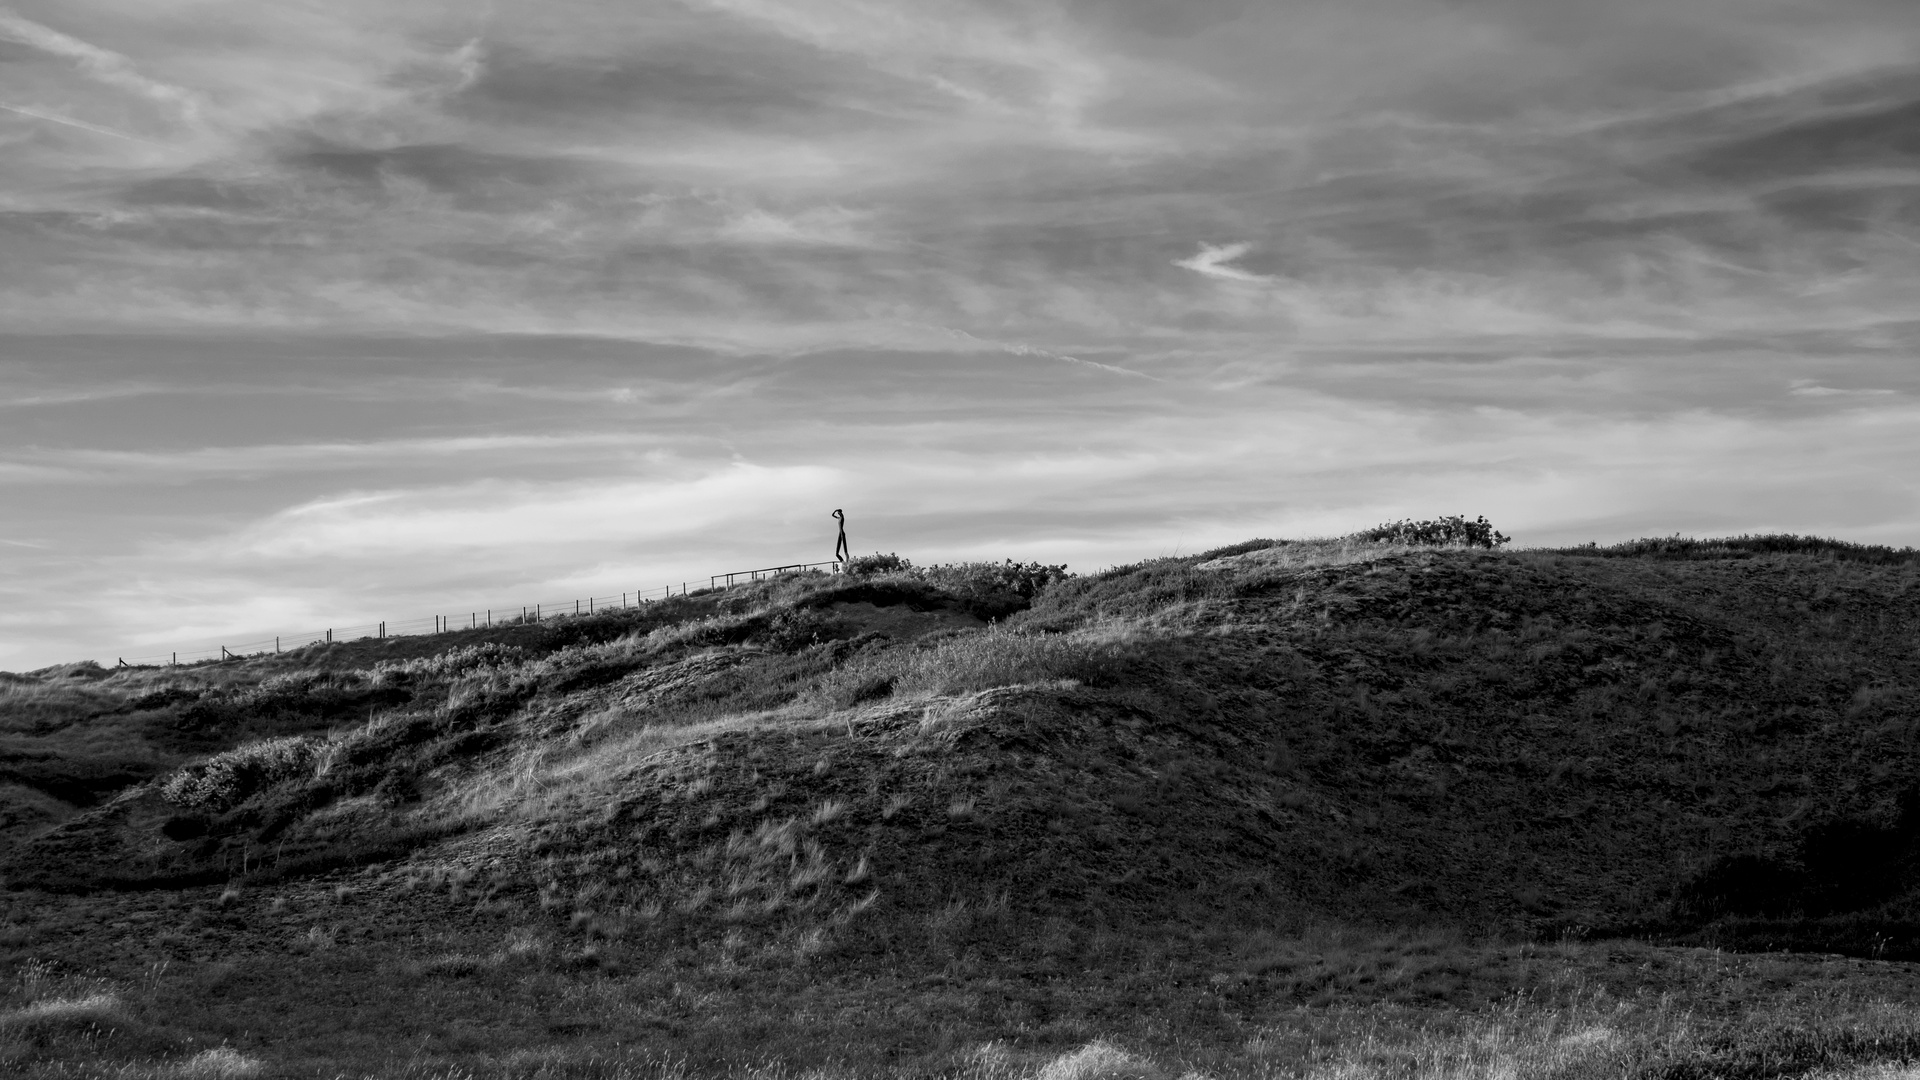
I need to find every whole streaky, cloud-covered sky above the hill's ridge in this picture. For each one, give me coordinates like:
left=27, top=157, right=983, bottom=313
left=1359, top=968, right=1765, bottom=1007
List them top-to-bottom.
left=0, top=0, right=1920, bottom=671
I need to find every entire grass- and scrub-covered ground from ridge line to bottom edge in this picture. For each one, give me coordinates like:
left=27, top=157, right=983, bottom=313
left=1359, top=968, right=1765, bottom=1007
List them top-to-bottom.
left=0, top=517, right=1920, bottom=1080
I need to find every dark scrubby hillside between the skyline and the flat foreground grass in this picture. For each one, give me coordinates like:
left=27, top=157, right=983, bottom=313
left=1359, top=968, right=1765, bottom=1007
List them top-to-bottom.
left=0, top=534, right=1920, bottom=1068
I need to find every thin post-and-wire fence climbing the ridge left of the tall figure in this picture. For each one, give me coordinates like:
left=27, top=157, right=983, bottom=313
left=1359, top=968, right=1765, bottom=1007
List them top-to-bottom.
left=115, top=561, right=845, bottom=667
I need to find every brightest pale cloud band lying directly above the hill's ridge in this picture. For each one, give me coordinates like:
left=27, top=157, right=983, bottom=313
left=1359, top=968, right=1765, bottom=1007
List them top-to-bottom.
left=0, top=371, right=1920, bottom=663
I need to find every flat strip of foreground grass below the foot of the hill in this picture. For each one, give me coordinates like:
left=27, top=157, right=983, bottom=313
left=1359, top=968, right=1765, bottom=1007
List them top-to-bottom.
left=0, top=888, right=1920, bottom=1080
